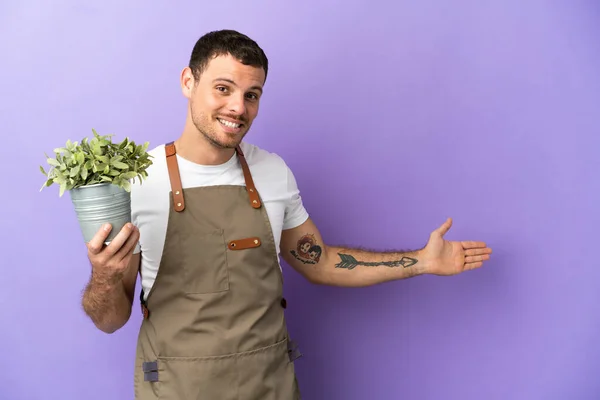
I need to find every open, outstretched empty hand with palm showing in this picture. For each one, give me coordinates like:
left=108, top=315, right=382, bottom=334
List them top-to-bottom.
left=422, top=218, right=492, bottom=275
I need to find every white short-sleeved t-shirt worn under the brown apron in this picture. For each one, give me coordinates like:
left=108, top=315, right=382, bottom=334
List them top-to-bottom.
left=131, top=142, right=308, bottom=298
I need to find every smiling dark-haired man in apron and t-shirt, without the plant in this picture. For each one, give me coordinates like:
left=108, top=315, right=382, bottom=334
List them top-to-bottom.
left=83, top=30, right=491, bottom=400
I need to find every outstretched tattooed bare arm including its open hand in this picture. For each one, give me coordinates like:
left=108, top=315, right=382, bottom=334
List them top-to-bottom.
left=281, top=219, right=491, bottom=287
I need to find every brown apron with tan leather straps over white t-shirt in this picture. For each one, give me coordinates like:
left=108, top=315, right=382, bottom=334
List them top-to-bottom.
left=134, top=142, right=300, bottom=400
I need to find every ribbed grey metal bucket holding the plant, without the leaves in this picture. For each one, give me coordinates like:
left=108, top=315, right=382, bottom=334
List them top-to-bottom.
left=69, top=183, right=131, bottom=244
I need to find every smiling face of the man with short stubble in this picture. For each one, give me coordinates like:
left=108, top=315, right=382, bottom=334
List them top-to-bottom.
left=184, top=55, right=265, bottom=148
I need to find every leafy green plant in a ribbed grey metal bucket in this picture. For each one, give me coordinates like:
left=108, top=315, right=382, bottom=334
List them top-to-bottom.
left=40, top=129, right=152, bottom=243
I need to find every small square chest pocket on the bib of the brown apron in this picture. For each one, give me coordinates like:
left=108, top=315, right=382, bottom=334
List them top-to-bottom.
left=182, top=229, right=229, bottom=294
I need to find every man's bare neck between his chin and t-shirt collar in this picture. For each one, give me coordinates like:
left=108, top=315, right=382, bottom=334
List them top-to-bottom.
left=175, top=124, right=235, bottom=165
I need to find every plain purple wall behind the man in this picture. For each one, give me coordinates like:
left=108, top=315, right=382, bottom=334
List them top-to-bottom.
left=0, top=0, right=600, bottom=400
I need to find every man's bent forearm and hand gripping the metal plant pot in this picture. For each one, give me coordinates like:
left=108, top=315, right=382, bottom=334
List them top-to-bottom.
left=82, top=226, right=140, bottom=333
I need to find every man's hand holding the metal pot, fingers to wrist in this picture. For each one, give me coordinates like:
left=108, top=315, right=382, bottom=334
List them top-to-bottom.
left=87, top=223, right=140, bottom=282
